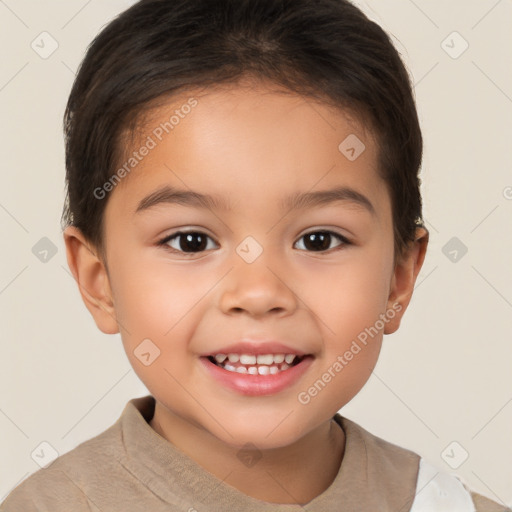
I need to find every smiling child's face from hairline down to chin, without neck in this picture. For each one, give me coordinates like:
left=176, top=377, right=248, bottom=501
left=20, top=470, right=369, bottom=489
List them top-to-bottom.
left=65, top=79, right=421, bottom=448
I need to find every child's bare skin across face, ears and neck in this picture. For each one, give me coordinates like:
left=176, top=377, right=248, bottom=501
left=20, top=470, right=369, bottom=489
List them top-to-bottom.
left=64, top=78, right=428, bottom=504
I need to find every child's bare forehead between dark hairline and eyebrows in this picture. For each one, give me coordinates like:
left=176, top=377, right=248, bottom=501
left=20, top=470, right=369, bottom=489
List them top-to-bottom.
left=109, top=83, right=383, bottom=220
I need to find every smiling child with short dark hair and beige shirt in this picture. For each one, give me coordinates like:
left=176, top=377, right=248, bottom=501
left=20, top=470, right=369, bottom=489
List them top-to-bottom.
left=0, top=0, right=505, bottom=512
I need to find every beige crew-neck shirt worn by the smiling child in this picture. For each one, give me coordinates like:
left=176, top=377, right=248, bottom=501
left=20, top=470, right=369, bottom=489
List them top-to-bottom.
left=0, top=395, right=504, bottom=512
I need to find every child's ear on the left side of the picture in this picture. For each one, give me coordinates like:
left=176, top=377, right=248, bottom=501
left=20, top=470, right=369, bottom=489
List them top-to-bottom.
left=64, top=226, right=119, bottom=334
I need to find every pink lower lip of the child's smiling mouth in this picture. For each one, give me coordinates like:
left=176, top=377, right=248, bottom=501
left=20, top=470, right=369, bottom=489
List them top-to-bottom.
left=199, top=356, right=313, bottom=396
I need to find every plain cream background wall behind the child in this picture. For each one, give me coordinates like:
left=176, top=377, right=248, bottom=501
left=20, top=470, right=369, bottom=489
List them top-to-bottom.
left=0, top=0, right=512, bottom=505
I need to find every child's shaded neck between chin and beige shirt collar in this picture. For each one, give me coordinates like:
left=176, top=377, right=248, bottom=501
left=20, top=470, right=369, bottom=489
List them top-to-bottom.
left=149, top=402, right=345, bottom=504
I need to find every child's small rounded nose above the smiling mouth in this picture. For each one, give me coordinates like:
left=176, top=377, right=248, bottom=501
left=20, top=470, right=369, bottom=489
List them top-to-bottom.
left=219, top=256, right=298, bottom=317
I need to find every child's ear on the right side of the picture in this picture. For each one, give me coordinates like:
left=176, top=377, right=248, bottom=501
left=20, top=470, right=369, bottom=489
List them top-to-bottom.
left=384, top=227, right=429, bottom=334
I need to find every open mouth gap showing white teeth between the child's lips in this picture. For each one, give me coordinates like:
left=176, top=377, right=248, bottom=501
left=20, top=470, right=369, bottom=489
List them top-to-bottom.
left=207, top=354, right=312, bottom=375
